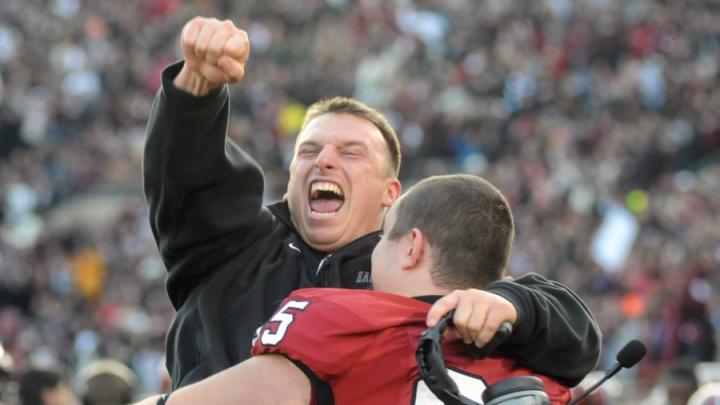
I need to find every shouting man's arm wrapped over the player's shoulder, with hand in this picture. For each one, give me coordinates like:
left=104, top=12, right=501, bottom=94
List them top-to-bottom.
left=428, top=274, right=602, bottom=386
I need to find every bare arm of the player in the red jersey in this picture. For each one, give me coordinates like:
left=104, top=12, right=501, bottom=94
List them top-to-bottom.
left=131, top=354, right=312, bottom=405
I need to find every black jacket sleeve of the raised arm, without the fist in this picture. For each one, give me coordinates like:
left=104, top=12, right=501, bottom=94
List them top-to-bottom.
left=143, top=62, right=272, bottom=309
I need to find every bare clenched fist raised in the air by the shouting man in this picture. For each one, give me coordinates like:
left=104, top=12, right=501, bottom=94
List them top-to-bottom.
left=174, top=17, right=250, bottom=95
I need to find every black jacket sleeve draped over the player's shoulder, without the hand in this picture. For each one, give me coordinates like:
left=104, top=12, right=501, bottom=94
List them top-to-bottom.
left=486, top=273, right=602, bottom=386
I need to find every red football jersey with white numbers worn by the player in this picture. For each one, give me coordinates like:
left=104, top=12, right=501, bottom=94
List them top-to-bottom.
left=252, top=288, right=570, bottom=404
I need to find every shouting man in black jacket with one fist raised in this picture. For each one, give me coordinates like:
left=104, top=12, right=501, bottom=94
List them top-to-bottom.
left=143, top=18, right=600, bottom=388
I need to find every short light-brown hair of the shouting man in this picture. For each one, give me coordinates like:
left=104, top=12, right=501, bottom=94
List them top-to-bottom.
left=300, top=97, right=402, bottom=177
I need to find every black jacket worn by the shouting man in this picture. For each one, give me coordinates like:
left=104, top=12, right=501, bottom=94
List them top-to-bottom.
left=143, top=63, right=601, bottom=388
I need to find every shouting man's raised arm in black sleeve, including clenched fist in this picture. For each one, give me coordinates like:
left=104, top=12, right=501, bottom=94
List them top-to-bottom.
left=143, top=18, right=271, bottom=308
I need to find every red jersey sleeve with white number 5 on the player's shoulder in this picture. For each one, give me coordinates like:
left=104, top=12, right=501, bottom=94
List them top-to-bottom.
left=252, top=292, right=375, bottom=381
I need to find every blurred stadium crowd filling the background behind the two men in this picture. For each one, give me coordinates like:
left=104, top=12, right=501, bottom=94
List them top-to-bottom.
left=0, top=0, right=720, bottom=403
